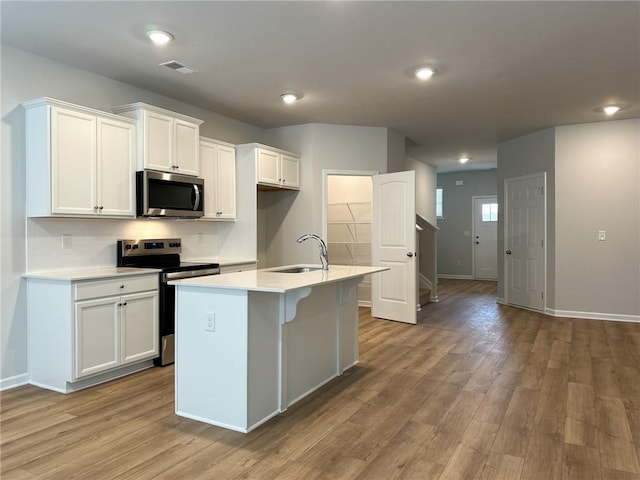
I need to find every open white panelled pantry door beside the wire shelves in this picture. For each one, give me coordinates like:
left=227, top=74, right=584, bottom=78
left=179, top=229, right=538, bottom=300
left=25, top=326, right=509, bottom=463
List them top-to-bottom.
left=371, top=171, right=418, bottom=324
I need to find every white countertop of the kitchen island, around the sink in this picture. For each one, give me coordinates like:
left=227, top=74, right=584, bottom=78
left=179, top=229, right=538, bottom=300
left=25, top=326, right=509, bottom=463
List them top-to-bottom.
left=169, top=265, right=389, bottom=293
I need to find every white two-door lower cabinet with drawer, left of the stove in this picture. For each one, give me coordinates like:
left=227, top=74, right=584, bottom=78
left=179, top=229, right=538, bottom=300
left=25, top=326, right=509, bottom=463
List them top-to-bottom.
left=27, top=273, right=159, bottom=393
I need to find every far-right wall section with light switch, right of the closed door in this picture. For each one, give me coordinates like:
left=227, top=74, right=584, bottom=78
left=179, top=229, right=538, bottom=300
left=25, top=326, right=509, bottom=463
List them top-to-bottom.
left=555, top=119, right=640, bottom=318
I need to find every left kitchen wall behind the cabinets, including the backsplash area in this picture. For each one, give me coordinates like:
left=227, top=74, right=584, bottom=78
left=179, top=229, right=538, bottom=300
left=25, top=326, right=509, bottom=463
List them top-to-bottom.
left=0, top=45, right=262, bottom=388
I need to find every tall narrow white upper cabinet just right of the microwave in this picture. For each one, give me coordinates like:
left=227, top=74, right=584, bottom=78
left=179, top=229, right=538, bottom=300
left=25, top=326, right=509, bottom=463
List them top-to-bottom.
left=200, top=137, right=236, bottom=220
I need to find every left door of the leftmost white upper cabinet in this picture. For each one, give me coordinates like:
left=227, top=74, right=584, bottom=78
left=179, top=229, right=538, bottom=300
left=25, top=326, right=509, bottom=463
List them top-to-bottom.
left=51, top=107, right=98, bottom=215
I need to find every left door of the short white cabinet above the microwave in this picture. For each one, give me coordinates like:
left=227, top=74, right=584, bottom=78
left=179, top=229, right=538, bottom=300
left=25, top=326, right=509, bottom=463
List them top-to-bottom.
left=141, top=111, right=174, bottom=172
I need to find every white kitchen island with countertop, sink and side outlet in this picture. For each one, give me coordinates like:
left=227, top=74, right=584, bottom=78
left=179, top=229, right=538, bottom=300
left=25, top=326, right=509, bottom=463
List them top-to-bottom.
left=171, top=265, right=387, bottom=433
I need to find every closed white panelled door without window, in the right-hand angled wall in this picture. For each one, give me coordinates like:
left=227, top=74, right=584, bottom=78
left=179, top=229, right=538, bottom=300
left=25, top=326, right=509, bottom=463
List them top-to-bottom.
left=505, top=174, right=546, bottom=310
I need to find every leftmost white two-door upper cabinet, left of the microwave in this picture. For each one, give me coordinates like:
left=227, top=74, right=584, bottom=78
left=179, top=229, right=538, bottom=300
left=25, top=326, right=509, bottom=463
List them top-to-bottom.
left=23, top=98, right=136, bottom=217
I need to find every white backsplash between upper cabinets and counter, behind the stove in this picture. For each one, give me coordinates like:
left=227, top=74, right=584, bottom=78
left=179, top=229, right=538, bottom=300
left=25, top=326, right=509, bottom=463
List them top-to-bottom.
left=26, top=218, right=228, bottom=272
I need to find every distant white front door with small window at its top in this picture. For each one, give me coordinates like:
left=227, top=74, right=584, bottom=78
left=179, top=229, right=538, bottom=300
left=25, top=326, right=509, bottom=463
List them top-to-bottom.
left=473, top=195, right=498, bottom=280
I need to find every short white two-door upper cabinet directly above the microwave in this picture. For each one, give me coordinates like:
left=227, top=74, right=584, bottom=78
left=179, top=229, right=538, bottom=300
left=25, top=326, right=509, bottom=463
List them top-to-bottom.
left=113, top=103, right=202, bottom=176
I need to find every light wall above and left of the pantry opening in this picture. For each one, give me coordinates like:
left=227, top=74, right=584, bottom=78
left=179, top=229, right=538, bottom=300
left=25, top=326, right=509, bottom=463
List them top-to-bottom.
left=258, top=124, right=387, bottom=266
